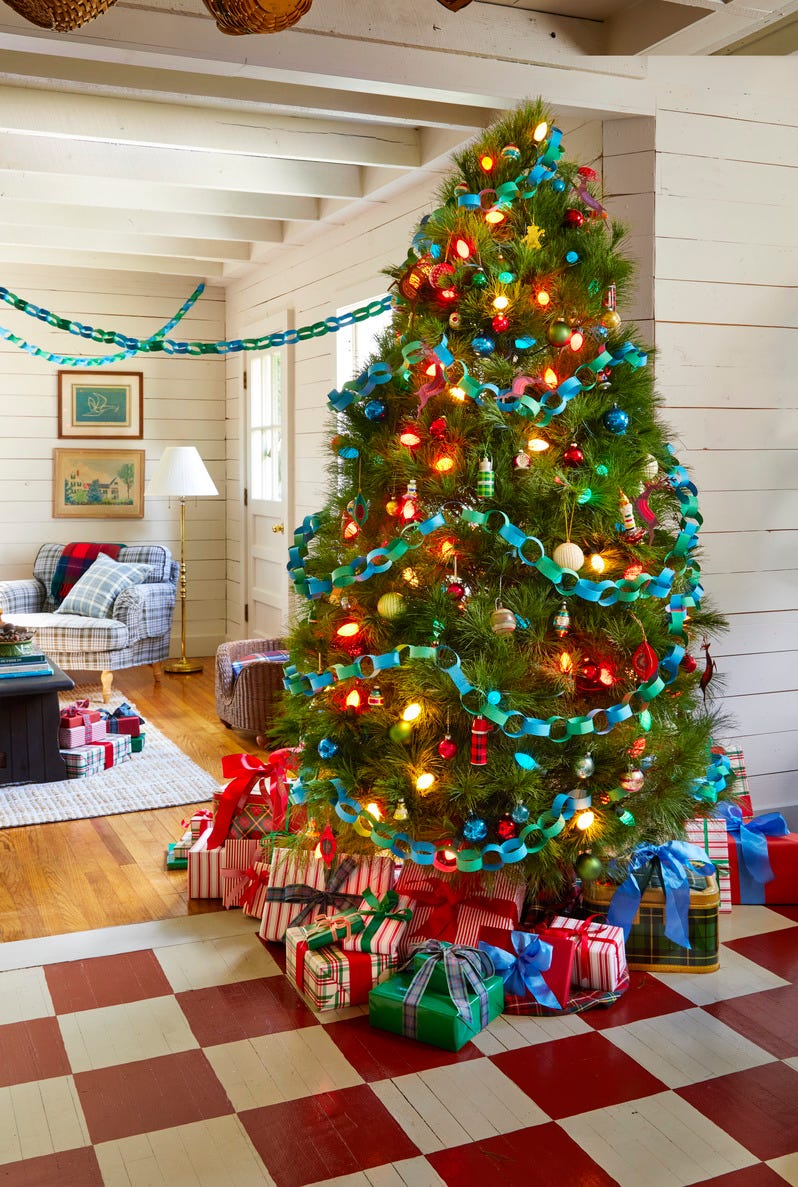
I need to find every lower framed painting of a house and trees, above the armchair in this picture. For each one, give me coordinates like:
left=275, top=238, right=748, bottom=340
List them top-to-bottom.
left=52, top=449, right=144, bottom=519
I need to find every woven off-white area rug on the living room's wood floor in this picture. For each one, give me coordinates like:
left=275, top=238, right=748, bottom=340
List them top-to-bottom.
left=0, top=685, right=221, bottom=829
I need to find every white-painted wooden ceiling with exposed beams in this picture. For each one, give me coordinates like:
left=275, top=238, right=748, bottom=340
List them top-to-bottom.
left=0, top=0, right=798, bottom=283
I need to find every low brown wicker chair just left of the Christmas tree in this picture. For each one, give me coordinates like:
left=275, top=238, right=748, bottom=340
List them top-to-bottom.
left=216, top=639, right=285, bottom=734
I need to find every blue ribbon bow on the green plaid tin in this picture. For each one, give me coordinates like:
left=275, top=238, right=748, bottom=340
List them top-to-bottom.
left=607, top=840, right=715, bottom=948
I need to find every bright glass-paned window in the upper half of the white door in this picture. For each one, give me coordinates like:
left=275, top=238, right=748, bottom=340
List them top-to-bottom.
left=248, top=350, right=283, bottom=503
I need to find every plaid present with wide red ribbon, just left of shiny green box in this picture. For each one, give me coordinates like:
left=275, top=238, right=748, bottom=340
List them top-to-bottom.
left=285, top=925, right=399, bottom=1010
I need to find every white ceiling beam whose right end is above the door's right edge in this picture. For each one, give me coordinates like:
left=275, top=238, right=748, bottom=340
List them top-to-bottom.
left=0, top=200, right=283, bottom=244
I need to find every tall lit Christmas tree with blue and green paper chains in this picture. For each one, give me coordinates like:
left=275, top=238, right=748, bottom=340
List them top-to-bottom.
left=273, top=102, right=723, bottom=891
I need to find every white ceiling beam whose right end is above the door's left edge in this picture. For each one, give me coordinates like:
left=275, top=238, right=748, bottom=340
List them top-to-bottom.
left=0, top=223, right=252, bottom=260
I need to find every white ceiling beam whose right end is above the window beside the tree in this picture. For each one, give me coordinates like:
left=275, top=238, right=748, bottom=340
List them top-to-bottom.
left=0, top=132, right=362, bottom=199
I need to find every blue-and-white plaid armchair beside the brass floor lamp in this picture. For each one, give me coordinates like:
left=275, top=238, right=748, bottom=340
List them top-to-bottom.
left=0, top=544, right=178, bottom=700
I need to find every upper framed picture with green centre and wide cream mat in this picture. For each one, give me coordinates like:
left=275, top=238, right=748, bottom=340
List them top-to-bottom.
left=58, top=370, right=144, bottom=439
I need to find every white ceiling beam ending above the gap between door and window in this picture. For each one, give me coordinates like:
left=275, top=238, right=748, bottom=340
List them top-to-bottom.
left=0, top=169, right=319, bottom=220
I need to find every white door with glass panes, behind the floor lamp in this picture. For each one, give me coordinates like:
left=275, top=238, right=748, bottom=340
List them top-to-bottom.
left=245, top=322, right=293, bottom=639
